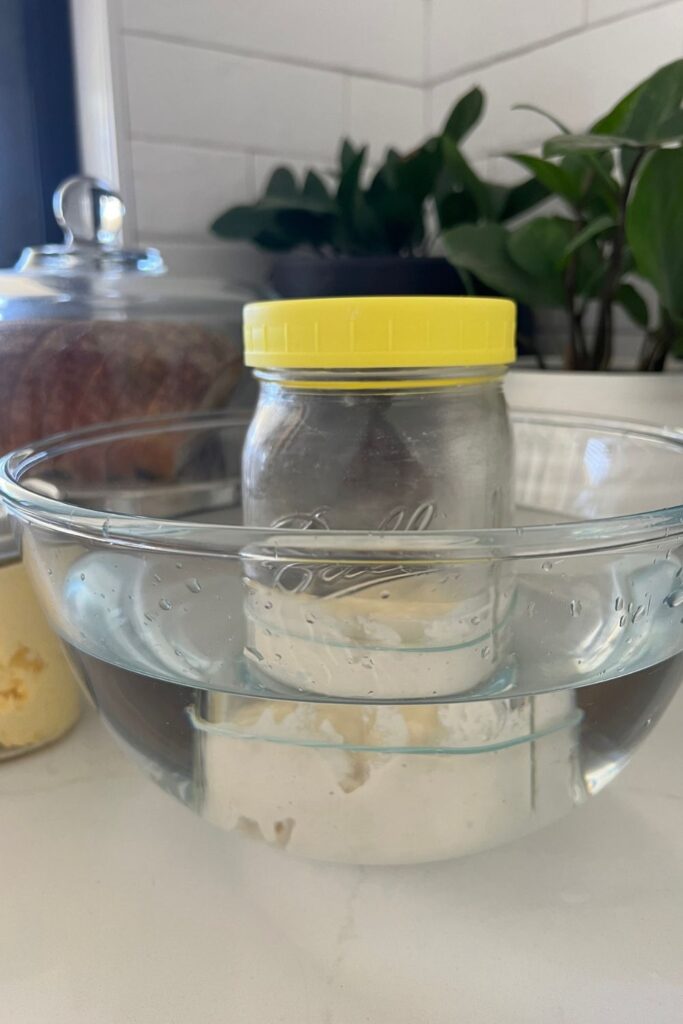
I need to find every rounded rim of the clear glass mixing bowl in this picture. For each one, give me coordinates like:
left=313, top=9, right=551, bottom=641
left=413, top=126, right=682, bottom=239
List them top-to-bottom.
left=0, top=408, right=683, bottom=562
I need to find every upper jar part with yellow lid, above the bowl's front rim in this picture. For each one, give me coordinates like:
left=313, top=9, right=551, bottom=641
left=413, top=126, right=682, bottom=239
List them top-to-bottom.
left=243, top=297, right=514, bottom=530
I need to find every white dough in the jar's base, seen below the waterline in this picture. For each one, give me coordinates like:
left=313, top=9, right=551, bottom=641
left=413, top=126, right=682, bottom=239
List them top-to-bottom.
left=198, top=692, right=578, bottom=864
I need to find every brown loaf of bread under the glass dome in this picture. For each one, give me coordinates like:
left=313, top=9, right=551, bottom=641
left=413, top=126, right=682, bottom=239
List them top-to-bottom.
left=0, top=321, right=241, bottom=482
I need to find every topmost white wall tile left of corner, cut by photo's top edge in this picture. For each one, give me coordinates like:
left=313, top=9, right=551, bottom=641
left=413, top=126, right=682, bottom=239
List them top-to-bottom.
left=123, top=0, right=424, bottom=82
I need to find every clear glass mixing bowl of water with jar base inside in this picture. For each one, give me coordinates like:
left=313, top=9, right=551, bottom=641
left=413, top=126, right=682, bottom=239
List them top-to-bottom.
left=0, top=413, right=683, bottom=863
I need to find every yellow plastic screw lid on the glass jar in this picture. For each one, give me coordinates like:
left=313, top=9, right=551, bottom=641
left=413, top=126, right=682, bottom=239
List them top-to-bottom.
left=244, top=296, right=515, bottom=370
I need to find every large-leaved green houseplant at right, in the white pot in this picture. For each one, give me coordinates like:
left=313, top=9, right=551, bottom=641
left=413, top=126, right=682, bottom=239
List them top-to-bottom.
left=443, top=60, right=683, bottom=370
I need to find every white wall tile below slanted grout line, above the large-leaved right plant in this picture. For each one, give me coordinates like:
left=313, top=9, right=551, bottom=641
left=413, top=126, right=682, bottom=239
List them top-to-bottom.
left=431, top=0, right=683, bottom=156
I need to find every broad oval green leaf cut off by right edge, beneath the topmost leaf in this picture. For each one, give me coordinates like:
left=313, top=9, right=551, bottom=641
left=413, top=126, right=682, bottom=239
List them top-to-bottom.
left=626, top=148, right=683, bottom=317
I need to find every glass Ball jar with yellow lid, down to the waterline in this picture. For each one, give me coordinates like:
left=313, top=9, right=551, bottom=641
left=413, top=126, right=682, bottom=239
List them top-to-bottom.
left=242, top=297, right=515, bottom=698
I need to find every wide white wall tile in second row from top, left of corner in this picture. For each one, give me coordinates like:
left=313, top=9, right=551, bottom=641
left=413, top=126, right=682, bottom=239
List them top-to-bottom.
left=125, top=37, right=343, bottom=157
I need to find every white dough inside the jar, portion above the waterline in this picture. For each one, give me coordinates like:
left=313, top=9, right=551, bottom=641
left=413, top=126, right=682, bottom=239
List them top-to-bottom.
left=245, top=568, right=510, bottom=700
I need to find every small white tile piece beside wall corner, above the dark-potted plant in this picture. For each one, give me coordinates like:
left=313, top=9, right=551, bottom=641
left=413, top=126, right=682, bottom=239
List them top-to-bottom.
left=348, top=78, right=425, bottom=161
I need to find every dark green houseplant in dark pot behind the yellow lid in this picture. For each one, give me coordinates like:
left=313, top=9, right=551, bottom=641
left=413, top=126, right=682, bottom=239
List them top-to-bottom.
left=212, top=88, right=547, bottom=297
